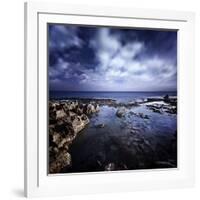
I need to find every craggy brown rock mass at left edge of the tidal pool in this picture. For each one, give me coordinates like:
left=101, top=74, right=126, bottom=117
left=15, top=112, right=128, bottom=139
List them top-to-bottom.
left=49, top=101, right=99, bottom=173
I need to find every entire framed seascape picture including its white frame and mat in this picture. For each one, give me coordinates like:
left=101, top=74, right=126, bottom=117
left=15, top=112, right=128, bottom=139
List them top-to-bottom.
left=25, top=3, right=194, bottom=197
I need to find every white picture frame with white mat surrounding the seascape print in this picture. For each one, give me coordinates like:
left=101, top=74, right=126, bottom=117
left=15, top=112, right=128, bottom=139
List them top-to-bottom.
left=24, top=3, right=194, bottom=197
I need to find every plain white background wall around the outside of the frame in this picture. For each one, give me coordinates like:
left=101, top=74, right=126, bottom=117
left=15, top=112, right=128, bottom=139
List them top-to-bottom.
left=0, top=0, right=200, bottom=200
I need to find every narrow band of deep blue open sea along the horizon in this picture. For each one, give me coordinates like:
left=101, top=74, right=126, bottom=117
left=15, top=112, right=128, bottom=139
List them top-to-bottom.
left=49, top=91, right=177, bottom=102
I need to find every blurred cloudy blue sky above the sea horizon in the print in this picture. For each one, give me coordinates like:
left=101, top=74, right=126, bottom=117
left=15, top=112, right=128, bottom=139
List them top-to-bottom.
left=48, top=24, right=177, bottom=91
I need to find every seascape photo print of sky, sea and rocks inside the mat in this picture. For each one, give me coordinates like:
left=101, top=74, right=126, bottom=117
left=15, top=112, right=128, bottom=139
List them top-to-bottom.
left=47, top=23, right=177, bottom=174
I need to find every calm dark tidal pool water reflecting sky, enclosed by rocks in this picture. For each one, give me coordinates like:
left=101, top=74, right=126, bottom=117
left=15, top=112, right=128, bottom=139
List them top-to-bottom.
left=62, top=105, right=177, bottom=172
